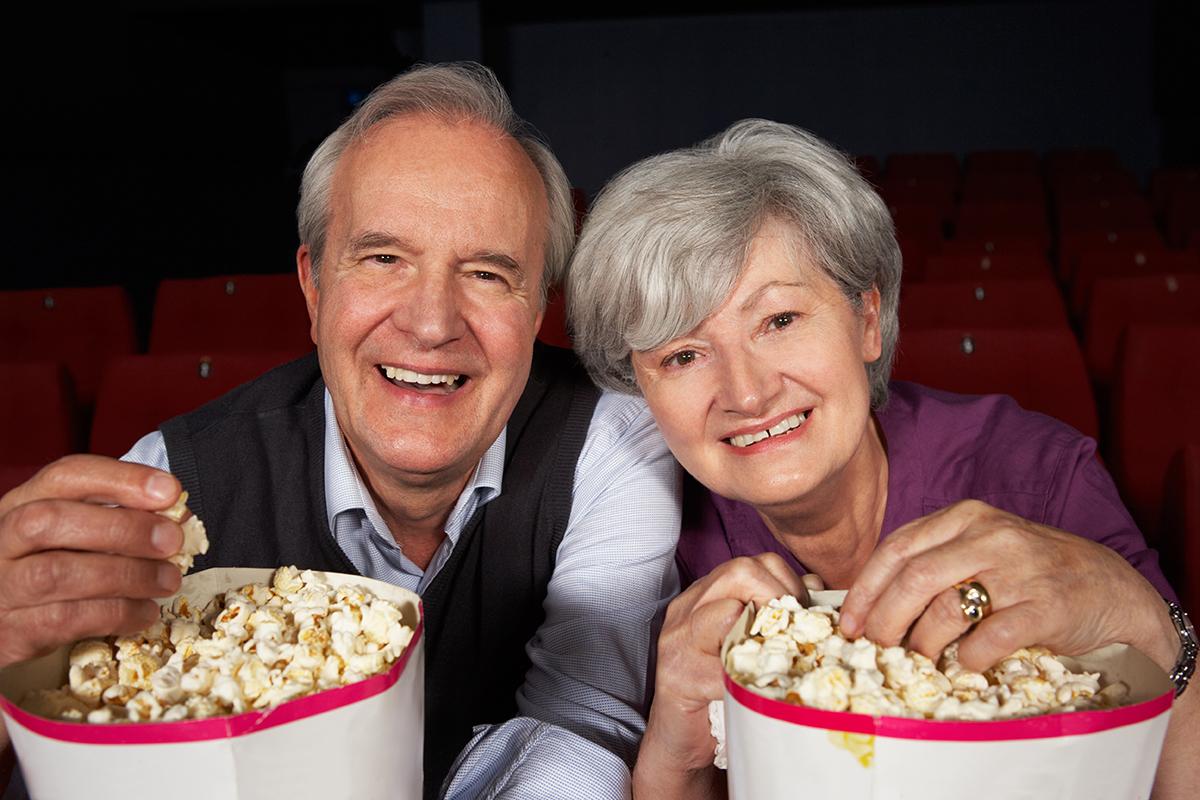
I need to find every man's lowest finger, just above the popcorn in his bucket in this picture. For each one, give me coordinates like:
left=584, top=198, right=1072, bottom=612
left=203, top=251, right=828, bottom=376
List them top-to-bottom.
left=0, top=597, right=158, bottom=667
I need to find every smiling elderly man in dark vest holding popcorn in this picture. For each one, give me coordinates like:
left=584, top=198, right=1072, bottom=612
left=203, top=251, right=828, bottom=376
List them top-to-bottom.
left=0, top=65, right=679, bottom=798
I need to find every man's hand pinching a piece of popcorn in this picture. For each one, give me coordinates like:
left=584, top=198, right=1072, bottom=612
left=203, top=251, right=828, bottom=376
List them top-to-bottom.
left=0, top=456, right=184, bottom=667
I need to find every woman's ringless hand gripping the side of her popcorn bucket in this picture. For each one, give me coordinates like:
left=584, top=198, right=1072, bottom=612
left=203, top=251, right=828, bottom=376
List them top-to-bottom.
left=634, top=553, right=808, bottom=800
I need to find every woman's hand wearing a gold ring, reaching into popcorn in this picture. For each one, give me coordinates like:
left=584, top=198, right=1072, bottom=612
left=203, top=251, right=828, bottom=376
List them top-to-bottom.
left=841, top=500, right=1177, bottom=669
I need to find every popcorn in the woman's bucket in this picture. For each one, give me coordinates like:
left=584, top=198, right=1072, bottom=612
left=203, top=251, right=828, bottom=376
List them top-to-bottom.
left=724, top=596, right=1128, bottom=720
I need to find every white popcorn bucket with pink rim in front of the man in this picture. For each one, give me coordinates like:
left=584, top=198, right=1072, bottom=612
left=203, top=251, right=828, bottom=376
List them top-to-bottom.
left=0, top=569, right=425, bottom=800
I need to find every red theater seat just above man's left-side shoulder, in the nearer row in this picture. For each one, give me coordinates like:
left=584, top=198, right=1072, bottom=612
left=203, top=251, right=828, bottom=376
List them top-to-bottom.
left=90, top=353, right=302, bottom=456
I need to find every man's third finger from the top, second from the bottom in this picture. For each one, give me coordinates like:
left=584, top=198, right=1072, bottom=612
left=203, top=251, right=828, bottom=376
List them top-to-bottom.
left=0, top=551, right=181, bottom=616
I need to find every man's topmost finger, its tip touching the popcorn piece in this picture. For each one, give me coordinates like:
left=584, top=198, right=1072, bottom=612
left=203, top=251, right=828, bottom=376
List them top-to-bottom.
left=0, top=453, right=181, bottom=516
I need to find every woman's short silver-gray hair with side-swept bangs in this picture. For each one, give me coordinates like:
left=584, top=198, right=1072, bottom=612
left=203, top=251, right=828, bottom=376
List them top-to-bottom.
left=566, top=120, right=900, bottom=408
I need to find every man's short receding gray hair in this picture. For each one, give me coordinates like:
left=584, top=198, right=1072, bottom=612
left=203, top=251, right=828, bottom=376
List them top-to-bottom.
left=296, top=61, right=575, bottom=302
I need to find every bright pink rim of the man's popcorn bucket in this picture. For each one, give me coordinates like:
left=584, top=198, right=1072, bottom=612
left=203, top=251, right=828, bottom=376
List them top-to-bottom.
left=0, top=618, right=425, bottom=745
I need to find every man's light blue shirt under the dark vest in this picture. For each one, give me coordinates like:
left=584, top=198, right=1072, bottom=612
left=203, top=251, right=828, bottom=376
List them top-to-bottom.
left=125, top=391, right=680, bottom=800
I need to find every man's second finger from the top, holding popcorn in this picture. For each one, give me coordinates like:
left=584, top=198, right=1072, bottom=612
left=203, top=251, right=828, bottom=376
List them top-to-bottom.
left=0, top=501, right=184, bottom=559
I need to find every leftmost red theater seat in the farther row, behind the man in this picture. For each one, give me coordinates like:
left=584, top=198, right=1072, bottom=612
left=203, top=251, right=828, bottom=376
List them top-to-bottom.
left=0, top=287, right=137, bottom=407
